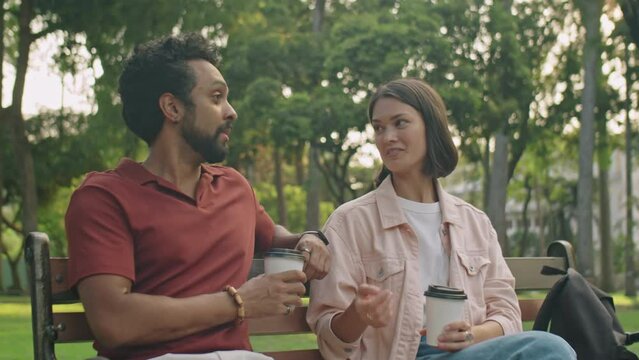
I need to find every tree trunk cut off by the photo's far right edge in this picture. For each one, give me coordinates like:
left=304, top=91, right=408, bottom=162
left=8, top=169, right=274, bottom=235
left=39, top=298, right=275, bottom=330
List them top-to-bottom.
left=624, top=43, right=639, bottom=297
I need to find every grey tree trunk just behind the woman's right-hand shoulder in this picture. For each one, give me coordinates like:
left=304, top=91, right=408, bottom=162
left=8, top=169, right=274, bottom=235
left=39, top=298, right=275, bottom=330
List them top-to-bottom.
left=487, top=129, right=510, bottom=256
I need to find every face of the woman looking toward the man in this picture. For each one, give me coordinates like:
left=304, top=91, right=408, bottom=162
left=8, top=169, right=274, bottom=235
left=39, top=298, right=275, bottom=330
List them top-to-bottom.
left=371, top=98, right=426, bottom=174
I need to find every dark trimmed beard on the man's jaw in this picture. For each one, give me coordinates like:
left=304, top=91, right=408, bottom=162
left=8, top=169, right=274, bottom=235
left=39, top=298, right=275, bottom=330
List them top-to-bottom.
left=182, top=111, right=230, bottom=163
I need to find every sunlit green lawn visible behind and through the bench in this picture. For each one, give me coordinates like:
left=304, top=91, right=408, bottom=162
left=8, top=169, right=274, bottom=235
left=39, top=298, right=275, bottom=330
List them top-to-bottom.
left=0, top=296, right=639, bottom=360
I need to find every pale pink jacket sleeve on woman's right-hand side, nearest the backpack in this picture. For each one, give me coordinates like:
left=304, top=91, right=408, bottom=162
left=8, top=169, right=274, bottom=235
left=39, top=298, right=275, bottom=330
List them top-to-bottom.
left=484, top=219, right=522, bottom=335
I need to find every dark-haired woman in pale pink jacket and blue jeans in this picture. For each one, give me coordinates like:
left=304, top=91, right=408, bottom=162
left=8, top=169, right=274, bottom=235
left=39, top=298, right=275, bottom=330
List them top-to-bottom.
left=308, top=79, right=575, bottom=360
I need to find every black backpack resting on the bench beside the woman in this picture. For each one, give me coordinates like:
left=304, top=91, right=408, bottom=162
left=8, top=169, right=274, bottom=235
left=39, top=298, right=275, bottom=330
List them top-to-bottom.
left=533, top=267, right=639, bottom=360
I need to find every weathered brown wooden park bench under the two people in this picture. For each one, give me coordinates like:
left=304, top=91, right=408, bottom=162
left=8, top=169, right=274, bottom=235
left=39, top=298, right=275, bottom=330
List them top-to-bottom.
left=25, top=232, right=575, bottom=360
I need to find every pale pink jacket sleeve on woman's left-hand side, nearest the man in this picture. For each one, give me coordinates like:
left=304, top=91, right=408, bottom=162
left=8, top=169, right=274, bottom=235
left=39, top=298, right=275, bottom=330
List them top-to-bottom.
left=306, top=214, right=365, bottom=359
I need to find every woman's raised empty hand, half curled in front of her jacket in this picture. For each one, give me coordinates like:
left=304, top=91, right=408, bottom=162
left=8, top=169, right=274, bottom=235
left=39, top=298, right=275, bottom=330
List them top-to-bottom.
left=353, top=284, right=393, bottom=328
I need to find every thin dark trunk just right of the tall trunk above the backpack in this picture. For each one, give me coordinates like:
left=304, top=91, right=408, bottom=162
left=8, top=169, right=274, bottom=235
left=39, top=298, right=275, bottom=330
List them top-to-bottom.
left=599, top=165, right=615, bottom=292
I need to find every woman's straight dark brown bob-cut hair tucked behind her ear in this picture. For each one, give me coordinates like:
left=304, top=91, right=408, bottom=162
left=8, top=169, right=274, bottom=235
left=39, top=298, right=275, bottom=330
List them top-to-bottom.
left=368, top=78, right=458, bottom=186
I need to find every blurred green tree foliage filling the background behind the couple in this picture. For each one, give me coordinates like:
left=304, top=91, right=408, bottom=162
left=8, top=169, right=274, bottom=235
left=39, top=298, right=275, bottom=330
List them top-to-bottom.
left=0, top=0, right=639, bottom=286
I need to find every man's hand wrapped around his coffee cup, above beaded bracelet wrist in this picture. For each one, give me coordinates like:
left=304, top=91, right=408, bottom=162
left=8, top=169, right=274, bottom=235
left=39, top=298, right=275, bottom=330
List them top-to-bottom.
left=237, top=270, right=306, bottom=318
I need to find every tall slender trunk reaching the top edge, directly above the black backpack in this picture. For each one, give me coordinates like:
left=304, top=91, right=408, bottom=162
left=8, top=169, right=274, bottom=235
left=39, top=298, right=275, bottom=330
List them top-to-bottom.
left=577, top=0, right=601, bottom=278
